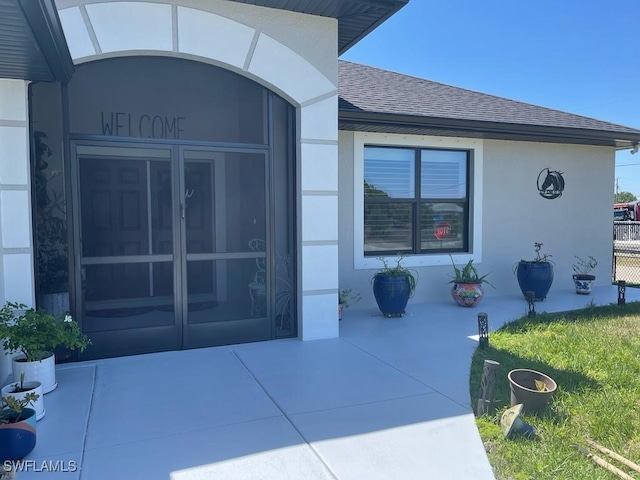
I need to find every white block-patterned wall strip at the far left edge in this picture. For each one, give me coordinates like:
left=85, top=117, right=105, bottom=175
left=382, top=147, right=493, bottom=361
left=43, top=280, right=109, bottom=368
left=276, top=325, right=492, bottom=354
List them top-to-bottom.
left=0, top=79, right=34, bottom=385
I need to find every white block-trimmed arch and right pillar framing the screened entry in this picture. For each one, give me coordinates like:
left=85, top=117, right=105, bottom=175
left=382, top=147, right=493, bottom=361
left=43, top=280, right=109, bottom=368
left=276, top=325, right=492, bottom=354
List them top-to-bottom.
left=56, top=0, right=338, bottom=340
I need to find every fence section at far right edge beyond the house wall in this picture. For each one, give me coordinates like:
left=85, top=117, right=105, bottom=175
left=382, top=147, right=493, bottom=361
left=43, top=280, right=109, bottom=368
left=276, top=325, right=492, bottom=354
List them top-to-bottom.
left=613, top=221, right=640, bottom=285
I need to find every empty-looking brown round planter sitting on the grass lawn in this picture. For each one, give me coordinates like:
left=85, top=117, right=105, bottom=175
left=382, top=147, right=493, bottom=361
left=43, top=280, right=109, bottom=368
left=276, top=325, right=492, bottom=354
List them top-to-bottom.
left=507, top=368, right=558, bottom=412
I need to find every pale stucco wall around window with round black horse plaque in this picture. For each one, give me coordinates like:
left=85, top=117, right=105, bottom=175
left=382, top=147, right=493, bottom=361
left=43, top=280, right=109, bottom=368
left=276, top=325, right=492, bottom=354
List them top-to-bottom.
left=339, top=128, right=615, bottom=307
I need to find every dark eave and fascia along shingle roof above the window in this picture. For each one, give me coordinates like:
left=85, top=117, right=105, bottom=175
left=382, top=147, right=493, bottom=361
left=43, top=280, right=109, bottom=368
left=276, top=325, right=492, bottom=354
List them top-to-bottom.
left=338, top=110, right=640, bottom=150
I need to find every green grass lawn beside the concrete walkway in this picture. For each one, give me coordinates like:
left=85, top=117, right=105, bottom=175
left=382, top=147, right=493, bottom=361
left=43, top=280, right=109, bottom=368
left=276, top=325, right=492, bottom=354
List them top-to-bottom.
left=470, top=303, right=640, bottom=480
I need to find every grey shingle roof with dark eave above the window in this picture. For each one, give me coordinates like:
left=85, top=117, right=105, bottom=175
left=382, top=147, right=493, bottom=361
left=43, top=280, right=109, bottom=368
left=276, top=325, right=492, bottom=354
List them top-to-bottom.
left=338, top=60, right=640, bottom=148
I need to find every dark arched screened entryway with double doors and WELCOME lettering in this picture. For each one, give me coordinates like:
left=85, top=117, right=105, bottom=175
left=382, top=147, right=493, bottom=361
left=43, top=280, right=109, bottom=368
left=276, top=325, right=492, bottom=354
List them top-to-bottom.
left=32, top=57, right=297, bottom=358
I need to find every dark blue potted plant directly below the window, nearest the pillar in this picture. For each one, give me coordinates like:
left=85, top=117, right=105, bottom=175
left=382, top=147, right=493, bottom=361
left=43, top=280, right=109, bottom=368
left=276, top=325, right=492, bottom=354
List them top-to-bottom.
left=371, top=255, right=417, bottom=317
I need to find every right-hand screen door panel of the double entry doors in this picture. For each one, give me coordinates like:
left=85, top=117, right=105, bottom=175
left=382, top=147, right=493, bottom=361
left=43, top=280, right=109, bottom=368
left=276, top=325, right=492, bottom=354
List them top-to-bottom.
left=181, top=149, right=271, bottom=347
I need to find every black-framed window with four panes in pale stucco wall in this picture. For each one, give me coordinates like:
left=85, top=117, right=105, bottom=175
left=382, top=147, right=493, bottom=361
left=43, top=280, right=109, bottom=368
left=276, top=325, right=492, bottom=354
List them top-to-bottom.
left=364, top=146, right=471, bottom=256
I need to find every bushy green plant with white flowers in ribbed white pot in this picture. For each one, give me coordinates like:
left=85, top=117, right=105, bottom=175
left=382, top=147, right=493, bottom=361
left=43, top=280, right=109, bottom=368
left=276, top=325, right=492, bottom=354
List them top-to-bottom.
left=0, top=302, right=91, bottom=362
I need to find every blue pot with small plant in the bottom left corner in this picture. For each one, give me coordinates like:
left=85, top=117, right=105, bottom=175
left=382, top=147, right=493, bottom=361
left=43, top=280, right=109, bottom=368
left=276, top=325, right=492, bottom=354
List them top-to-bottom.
left=0, top=393, right=38, bottom=465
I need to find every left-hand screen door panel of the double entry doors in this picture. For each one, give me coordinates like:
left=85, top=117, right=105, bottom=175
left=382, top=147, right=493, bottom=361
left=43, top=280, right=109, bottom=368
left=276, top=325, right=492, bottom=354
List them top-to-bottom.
left=76, top=145, right=181, bottom=357
